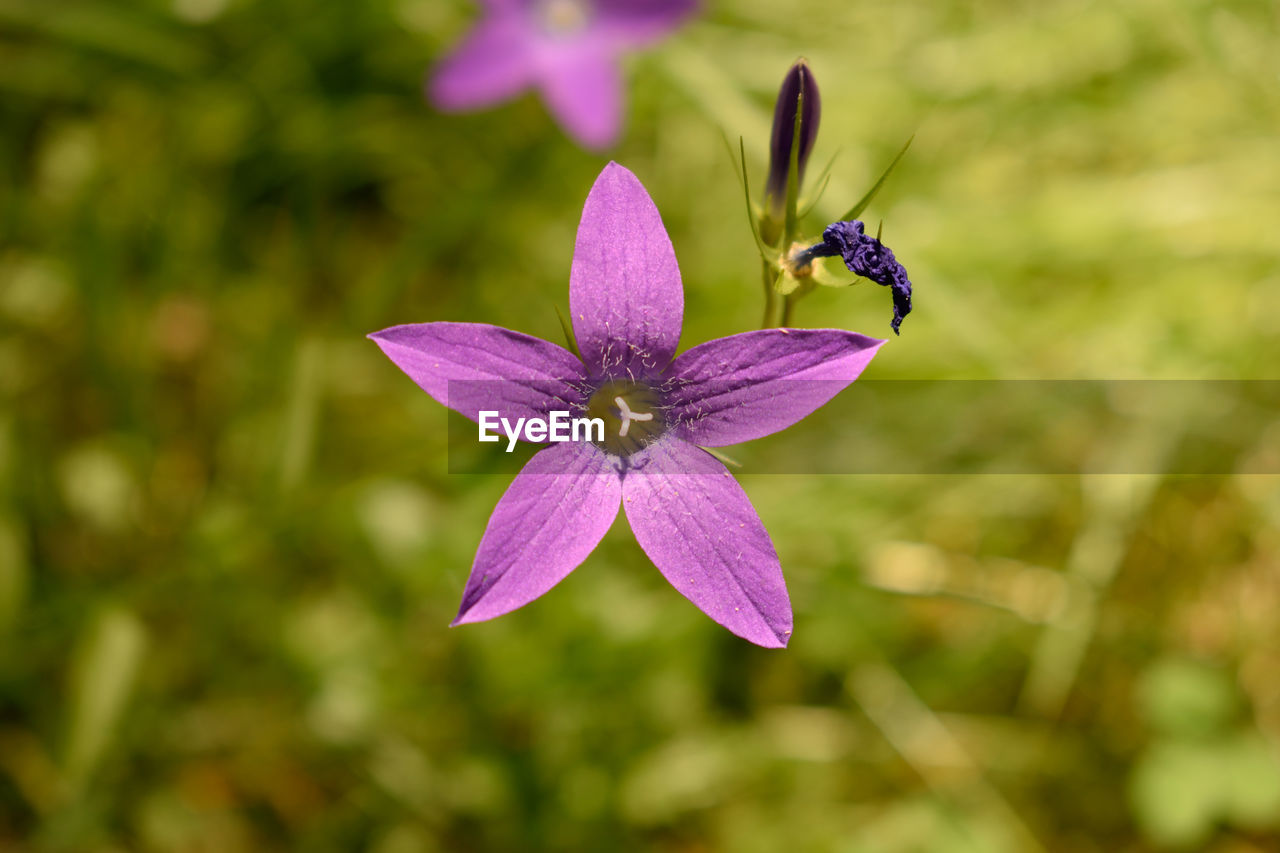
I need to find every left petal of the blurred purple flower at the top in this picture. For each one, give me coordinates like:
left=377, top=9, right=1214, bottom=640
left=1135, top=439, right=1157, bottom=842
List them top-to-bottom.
left=428, top=12, right=535, bottom=110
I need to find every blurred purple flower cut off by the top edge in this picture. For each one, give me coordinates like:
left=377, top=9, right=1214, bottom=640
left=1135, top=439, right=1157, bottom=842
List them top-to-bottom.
left=430, top=0, right=696, bottom=149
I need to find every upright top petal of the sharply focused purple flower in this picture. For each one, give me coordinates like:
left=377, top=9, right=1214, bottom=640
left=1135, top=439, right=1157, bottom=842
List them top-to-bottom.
left=568, top=163, right=685, bottom=377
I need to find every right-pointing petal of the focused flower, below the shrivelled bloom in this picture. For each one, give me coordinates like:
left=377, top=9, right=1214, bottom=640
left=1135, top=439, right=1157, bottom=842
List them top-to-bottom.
left=667, top=329, right=884, bottom=447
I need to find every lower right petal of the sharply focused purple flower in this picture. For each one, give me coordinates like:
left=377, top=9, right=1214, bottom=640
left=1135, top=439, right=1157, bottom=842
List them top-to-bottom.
left=622, top=438, right=791, bottom=648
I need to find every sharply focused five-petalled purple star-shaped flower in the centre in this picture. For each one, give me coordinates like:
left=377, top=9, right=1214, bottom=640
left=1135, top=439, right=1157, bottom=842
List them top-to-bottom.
left=370, top=163, right=884, bottom=647
